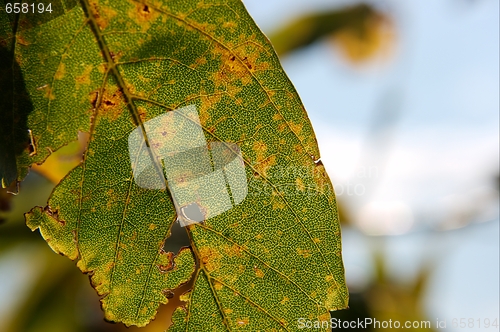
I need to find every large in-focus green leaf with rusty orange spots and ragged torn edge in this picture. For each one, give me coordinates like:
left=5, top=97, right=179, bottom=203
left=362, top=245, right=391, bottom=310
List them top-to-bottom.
left=0, top=0, right=347, bottom=331
